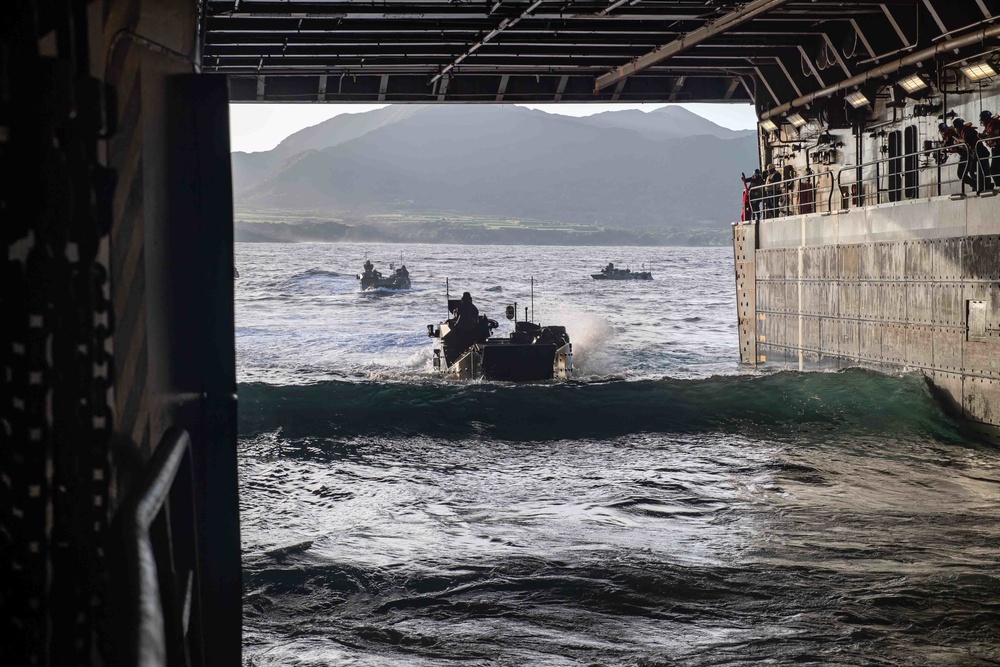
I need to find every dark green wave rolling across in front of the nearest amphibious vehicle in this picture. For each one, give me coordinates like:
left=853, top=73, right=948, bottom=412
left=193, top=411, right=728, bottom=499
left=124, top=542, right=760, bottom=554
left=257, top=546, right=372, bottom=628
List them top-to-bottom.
left=239, top=369, right=960, bottom=441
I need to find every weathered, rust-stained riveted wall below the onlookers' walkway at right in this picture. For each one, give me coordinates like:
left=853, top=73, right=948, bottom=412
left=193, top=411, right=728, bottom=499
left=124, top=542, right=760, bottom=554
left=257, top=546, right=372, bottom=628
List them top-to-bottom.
left=748, top=197, right=1000, bottom=434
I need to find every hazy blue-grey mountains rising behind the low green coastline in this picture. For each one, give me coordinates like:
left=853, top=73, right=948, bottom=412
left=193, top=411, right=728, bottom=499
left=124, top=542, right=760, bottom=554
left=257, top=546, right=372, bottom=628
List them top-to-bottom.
left=233, top=105, right=757, bottom=237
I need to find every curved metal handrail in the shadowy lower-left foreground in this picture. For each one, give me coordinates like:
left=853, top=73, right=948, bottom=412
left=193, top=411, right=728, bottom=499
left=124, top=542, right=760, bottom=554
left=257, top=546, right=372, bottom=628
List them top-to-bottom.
left=122, top=428, right=204, bottom=667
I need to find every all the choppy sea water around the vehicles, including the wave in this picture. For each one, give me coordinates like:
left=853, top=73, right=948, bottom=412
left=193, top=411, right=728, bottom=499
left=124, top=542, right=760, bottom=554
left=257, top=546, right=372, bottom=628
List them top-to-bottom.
left=236, top=244, right=1000, bottom=667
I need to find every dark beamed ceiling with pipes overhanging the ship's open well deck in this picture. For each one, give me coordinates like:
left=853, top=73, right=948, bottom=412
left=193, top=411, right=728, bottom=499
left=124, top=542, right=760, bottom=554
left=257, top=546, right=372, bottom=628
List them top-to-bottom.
left=201, top=0, right=1000, bottom=110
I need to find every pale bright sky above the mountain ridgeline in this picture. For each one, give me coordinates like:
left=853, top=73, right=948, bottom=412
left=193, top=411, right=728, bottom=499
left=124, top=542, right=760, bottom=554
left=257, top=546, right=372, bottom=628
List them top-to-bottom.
left=229, top=103, right=757, bottom=153
